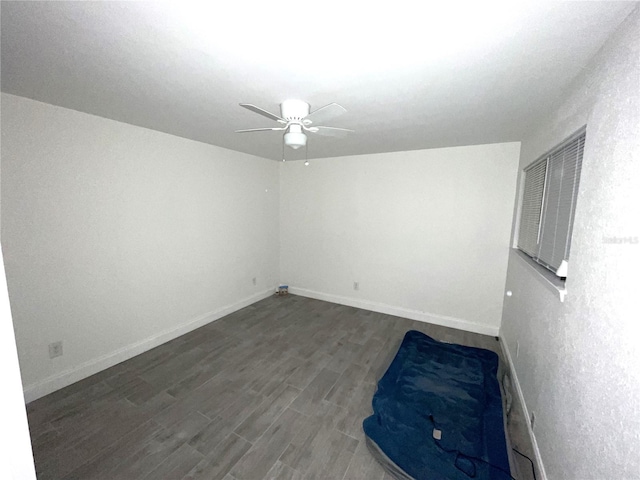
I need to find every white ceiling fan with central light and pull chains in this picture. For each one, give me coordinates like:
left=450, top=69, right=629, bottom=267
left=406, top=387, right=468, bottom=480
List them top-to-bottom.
left=236, top=100, right=353, bottom=150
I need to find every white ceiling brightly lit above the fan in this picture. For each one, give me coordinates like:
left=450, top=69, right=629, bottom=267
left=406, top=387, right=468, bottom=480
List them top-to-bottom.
left=1, top=0, right=637, bottom=159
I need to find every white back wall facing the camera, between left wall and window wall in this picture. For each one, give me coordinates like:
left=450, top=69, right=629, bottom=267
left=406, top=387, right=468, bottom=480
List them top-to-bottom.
left=280, top=143, right=520, bottom=335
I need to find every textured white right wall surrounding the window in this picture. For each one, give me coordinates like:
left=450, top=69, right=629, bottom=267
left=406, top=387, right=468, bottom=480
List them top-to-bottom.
left=501, top=8, right=640, bottom=480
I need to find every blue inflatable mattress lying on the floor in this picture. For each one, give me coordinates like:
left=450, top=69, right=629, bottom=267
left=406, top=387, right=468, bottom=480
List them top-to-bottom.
left=363, top=330, right=511, bottom=480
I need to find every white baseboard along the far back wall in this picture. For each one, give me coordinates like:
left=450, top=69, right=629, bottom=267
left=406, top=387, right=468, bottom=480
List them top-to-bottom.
left=289, top=287, right=499, bottom=337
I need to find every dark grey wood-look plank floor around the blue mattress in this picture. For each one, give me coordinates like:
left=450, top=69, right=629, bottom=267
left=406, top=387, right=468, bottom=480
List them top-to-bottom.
left=27, top=295, right=530, bottom=480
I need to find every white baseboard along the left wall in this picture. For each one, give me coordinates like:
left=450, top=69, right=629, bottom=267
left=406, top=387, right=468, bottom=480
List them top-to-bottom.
left=24, top=287, right=275, bottom=403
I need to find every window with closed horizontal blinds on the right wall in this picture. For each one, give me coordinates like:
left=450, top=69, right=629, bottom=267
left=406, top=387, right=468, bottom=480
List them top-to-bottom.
left=517, top=129, right=586, bottom=278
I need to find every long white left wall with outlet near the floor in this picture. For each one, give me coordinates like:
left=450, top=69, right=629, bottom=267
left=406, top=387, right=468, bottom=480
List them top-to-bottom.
left=2, top=94, right=279, bottom=400
